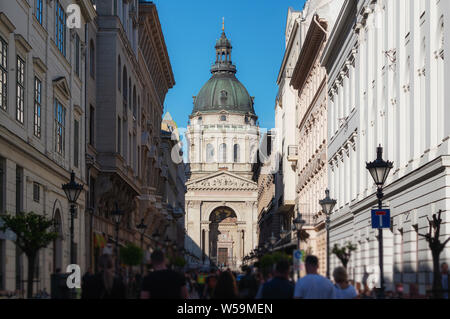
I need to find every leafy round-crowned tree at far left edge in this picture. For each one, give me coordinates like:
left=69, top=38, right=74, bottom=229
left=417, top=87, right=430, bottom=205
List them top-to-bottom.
left=0, top=212, right=58, bottom=298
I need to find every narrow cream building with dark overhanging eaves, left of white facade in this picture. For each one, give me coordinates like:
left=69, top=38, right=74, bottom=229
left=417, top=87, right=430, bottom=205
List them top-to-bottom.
left=288, top=0, right=343, bottom=275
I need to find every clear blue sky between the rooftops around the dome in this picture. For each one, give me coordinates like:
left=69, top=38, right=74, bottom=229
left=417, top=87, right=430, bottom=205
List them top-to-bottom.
left=153, top=0, right=304, bottom=129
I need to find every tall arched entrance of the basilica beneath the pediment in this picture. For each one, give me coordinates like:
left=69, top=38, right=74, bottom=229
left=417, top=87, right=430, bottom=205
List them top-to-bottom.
left=209, top=206, right=239, bottom=268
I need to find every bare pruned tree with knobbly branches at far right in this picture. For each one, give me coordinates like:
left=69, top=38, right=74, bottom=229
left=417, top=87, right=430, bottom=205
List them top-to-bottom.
left=419, top=210, right=450, bottom=298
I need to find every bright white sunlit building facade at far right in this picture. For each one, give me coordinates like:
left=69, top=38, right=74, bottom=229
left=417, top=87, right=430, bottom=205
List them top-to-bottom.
left=322, top=0, right=450, bottom=295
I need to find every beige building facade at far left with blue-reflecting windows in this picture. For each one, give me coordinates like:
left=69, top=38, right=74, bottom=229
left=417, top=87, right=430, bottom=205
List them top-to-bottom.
left=0, top=0, right=96, bottom=295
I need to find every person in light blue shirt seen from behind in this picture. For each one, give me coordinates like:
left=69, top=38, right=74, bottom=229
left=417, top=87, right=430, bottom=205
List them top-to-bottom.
left=294, top=255, right=336, bottom=299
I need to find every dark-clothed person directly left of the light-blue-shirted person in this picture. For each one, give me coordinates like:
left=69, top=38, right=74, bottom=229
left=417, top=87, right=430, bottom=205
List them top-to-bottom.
left=261, top=259, right=295, bottom=299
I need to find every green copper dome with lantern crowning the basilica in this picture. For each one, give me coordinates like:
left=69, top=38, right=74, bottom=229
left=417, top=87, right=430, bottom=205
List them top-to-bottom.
left=192, top=32, right=255, bottom=115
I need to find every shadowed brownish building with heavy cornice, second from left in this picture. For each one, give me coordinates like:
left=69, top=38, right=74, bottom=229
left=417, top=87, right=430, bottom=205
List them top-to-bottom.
left=87, top=0, right=175, bottom=269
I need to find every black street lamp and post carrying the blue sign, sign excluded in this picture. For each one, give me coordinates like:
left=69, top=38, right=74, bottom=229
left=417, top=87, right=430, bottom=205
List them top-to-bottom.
left=366, top=145, right=394, bottom=299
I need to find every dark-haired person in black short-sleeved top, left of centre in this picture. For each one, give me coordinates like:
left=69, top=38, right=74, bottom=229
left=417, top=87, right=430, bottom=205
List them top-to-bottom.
left=141, top=250, right=188, bottom=299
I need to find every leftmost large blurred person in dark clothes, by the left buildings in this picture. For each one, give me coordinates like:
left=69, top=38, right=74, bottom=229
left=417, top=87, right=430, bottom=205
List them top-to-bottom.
left=81, top=254, right=126, bottom=299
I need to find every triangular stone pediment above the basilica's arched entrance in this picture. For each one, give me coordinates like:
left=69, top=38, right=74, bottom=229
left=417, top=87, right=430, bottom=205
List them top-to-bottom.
left=186, top=172, right=258, bottom=191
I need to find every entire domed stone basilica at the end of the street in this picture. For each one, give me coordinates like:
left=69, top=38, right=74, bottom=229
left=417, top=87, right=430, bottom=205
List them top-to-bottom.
left=185, top=26, right=259, bottom=269
